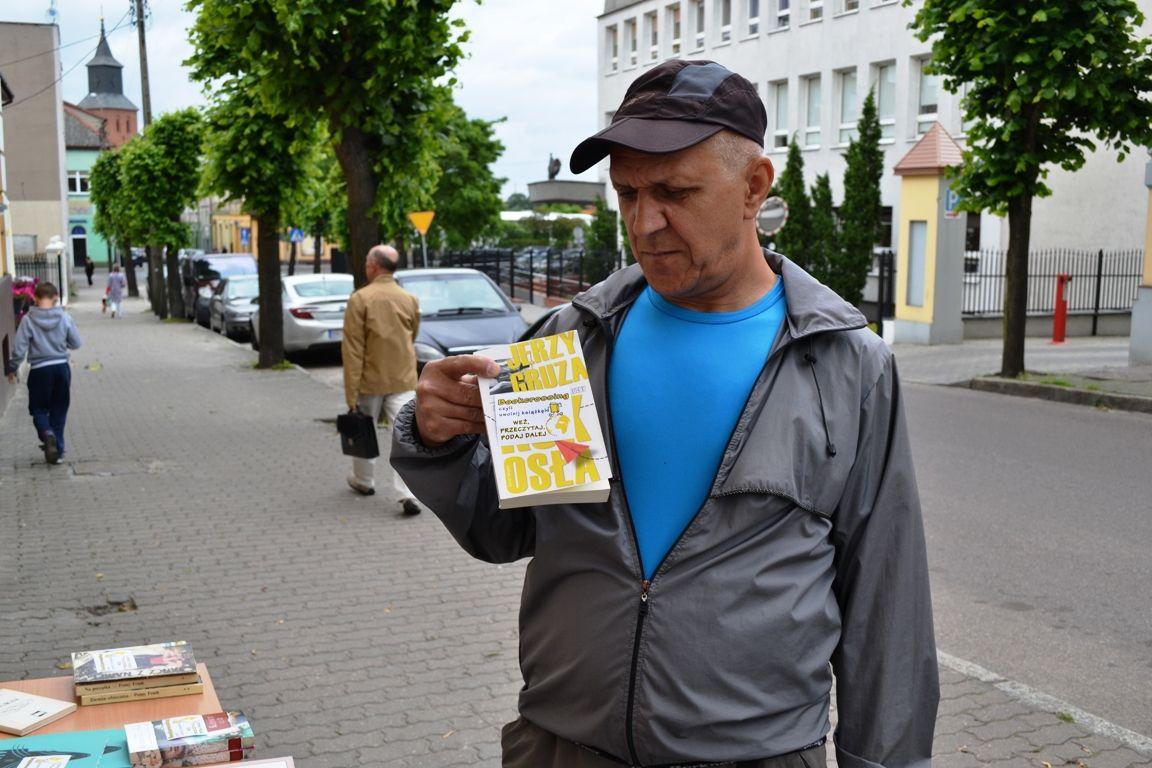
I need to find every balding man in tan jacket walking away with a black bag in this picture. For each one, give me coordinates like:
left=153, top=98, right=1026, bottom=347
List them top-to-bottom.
left=341, top=245, right=420, bottom=515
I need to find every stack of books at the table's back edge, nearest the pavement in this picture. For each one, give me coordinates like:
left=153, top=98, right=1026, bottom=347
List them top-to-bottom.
left=73, top=640, right=204, bottom=706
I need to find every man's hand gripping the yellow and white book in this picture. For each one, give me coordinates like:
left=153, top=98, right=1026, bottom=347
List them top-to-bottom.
left=416, top=355, right=500, bottom=448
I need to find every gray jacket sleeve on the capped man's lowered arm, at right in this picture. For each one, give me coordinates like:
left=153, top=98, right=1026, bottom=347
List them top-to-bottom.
left=832, top=351, right=940, bottom=768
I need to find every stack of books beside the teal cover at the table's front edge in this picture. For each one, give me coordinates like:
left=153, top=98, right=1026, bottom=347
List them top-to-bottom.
left=124, top=712, right=252, bottom=768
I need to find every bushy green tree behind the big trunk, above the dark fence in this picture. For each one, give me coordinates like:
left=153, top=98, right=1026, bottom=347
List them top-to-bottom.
left=430, top=106, right=505, bottom=250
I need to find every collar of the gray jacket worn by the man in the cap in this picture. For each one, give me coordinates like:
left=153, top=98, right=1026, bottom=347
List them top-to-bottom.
left=573, top=249, right=867, bottom=339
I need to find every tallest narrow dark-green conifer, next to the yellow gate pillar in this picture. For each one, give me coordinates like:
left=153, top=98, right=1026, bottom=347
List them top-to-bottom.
left=827, top=91, right=884, bottom=305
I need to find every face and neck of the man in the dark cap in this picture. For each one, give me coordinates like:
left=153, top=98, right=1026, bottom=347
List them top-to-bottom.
left=609, top=140, right=772, bottom=303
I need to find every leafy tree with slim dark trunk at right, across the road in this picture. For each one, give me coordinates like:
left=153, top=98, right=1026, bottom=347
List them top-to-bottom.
left=905, top=0, right=1152, bottom=377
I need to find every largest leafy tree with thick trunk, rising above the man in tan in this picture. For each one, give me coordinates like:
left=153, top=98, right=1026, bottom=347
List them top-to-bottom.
left=185, top=0, right=467, bottom=286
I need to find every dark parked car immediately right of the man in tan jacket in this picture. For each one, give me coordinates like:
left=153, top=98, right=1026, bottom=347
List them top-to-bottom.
left=396, top=268, right=526, bottom=368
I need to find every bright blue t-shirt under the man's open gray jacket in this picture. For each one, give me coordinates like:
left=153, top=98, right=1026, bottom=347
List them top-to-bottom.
left=608, top=279, right=787, bottom=579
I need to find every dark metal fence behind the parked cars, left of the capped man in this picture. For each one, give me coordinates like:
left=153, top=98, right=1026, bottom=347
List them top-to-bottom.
left=437, top=248, right=623, bottom=303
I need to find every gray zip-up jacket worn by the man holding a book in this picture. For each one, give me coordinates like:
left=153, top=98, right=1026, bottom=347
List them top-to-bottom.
left=392, top=252, right=939, bottom=768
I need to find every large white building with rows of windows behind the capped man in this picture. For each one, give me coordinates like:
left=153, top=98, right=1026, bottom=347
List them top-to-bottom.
left=597, top=0, right=1152, bottom=249
